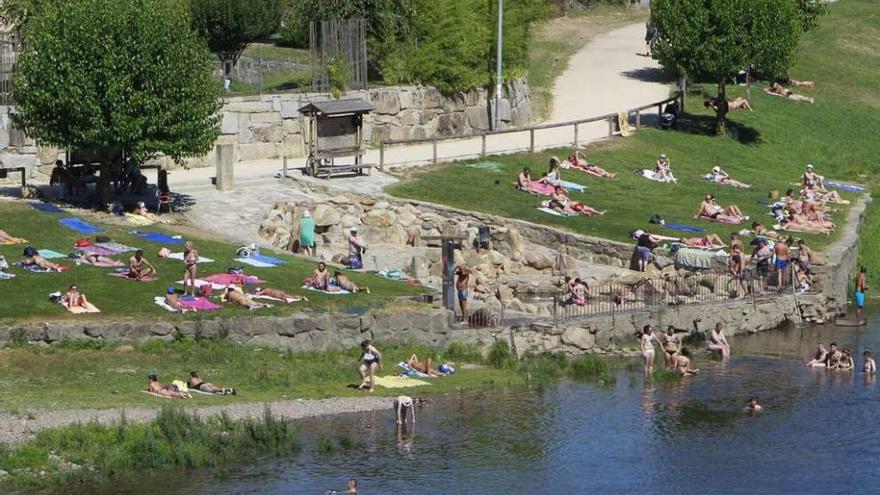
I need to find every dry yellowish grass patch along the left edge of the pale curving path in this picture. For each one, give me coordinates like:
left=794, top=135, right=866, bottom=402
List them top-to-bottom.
left=528, top=3, right=648, bottom=122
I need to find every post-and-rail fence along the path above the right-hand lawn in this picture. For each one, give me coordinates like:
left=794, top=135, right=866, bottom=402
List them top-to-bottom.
left=379, top=91, right=684, bottom=167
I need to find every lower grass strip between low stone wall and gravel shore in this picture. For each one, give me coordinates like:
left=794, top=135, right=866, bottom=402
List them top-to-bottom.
left=0, top=339, right=523, bottom=415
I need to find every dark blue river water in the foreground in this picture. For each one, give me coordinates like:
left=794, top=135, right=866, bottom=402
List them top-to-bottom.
left=74, top=316, right=880, bottom=495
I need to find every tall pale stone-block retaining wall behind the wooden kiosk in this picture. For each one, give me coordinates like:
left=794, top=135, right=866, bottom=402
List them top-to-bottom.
left=182, top=80, right=531, bottom=167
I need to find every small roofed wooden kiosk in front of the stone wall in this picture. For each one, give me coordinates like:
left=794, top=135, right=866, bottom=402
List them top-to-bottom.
left=299, top=98, right=373, bottom=179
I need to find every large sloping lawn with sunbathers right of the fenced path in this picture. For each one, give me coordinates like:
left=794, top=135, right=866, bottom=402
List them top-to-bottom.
left=389, top=0, right=880, bottom=254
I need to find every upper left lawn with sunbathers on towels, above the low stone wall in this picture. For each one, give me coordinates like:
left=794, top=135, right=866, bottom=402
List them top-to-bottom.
left=0, top=202, right=424, bottom=323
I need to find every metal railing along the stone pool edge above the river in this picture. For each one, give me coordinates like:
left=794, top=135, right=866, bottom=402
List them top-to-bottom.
left=551, top=267, right=796, bottom=325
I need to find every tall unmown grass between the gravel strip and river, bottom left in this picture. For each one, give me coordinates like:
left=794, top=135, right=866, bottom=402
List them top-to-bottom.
left=0, top=408, right=299, bottom=487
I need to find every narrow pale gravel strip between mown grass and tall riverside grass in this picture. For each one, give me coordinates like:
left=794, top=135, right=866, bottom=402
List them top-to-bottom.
left=0, top=397, right=392, bottom=444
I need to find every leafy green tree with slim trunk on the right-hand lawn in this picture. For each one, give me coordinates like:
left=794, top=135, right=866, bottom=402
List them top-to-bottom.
left=651, top=0, right=809, bottom=133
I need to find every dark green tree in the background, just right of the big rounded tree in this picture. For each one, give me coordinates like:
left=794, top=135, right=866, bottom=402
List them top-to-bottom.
left=190, top=0, right=283, bottom=76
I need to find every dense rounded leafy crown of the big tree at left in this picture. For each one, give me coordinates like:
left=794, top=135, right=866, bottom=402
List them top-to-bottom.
left=13, top=0, right=219, bottom=202
